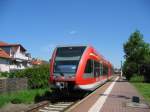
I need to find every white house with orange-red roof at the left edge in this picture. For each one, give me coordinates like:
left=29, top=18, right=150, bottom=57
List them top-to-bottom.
left=0, top=41, right=32, bottom=72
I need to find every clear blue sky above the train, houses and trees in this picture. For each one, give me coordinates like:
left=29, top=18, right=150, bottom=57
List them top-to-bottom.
left=0, top=0, right=150, bottom=67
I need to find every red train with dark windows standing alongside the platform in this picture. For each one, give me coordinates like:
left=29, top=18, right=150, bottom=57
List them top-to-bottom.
left=49, top=46, right=112, bottom=91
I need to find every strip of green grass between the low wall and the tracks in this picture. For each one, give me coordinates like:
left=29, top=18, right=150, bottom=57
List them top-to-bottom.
left=0, top=88, right=49, bottom=107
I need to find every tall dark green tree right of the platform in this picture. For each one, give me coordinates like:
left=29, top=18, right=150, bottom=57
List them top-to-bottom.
left=123, top=31, right=150, bottom=81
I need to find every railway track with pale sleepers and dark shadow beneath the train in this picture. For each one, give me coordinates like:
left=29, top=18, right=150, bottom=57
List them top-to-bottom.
left=23, top=91, right=90, bottom=112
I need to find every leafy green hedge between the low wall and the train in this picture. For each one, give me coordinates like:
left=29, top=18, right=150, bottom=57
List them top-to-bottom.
left=16, top=64, right=49, bottom=88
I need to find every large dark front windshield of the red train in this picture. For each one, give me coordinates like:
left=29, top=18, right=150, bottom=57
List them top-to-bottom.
left=54, top=47, right=85, bottom=74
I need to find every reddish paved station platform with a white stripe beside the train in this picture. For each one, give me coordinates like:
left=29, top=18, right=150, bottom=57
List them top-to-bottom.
left=67, top=76, right=150, bottom=112
